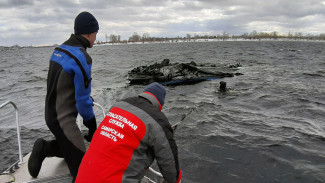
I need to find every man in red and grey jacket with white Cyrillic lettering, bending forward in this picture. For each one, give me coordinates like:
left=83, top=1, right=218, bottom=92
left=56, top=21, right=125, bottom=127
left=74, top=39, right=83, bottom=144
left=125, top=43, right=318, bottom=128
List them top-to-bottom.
left=76, top=83, right=181, bottom=183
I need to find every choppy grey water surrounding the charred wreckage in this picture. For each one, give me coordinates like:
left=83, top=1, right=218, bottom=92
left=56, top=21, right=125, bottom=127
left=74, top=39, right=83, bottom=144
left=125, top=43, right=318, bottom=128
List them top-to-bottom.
left=0, top=41, right=325, bottom=183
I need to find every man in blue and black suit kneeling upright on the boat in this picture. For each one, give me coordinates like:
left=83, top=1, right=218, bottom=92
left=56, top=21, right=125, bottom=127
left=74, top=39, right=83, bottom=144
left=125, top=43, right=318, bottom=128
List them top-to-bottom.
left=28, top=12, right=99, bottom=181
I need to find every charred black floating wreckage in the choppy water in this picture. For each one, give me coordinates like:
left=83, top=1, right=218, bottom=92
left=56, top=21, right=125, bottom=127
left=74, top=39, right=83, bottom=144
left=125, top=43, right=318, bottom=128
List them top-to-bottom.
left=128, top=59, right=242, bottom=86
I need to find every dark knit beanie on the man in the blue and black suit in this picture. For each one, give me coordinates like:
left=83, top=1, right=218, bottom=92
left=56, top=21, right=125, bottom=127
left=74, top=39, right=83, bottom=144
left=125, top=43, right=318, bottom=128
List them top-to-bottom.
left=74, top=11, right=99, bottom=35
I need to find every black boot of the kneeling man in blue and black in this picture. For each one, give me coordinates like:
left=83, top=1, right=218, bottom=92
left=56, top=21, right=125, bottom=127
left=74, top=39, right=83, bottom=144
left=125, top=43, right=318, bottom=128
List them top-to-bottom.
left=28, top=139, right=47, bottom=178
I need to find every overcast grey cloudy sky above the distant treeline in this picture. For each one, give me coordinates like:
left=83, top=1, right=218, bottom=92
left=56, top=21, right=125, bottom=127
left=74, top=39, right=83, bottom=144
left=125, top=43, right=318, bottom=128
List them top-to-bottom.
left=0, top=0, right=325, bottom=46
